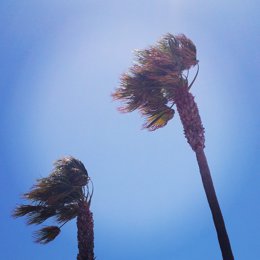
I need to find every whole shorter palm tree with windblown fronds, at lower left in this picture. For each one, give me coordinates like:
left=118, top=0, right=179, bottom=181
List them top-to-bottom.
left=13, top=156, right=94, bottom=260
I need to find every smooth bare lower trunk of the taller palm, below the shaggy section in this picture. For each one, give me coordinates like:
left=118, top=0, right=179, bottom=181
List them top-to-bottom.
left=196, top=149, right=234, bottom=260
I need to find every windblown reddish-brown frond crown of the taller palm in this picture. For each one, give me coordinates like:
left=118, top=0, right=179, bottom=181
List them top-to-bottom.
left=112, top=34, right=198, bottom=130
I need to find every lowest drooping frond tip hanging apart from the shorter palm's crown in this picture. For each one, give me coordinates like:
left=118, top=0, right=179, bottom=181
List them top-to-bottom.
left=34, top=226, right=60, bottom=244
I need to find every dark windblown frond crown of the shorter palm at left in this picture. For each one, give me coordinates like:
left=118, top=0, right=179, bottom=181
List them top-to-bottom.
left=13, top=156, right=91, bottom=244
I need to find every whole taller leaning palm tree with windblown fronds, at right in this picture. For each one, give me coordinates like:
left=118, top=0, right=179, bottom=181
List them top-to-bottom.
left=112, top=34, right=234, bottom=260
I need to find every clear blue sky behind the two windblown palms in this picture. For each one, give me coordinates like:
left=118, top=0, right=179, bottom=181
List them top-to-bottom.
left=0, top=0, right=260, bottom=260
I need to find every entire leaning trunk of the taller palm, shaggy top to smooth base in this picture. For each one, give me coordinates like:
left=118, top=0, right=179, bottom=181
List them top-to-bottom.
left=176, top=85, right=234, bottom=260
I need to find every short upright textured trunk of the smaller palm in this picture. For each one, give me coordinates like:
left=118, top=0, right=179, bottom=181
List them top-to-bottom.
left=77, top=201, right=95, bottom=260
